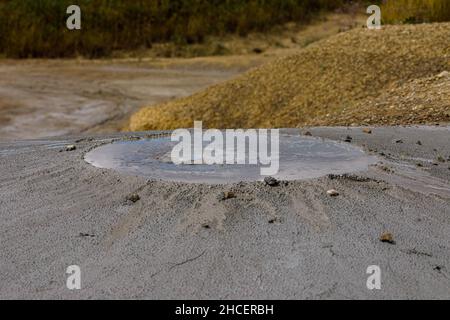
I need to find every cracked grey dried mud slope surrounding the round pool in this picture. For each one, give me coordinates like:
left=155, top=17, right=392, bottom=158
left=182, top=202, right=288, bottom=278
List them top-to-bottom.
left=0, top=127, right=450, bottom=299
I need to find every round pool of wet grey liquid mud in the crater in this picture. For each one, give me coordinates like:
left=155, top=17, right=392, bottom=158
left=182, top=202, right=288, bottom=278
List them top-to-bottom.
left=85, top=132, right=376, bottom=184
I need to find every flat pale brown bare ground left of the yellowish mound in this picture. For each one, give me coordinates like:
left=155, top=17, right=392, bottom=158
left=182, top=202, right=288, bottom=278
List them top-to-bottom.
left=0, top=60, right=246, bottom=140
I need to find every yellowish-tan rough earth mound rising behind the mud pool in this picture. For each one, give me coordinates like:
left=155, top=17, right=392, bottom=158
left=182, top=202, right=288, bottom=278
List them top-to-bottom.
left=130, top=23, right=450, bottom=130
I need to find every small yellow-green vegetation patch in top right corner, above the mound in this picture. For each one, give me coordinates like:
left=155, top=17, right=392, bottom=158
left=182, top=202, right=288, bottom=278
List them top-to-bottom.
left=382, top=0, right=450, bottom=23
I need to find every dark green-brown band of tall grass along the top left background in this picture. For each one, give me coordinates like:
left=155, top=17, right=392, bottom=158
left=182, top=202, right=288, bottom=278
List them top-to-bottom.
left=0, top=0, right=349, bottom=58
